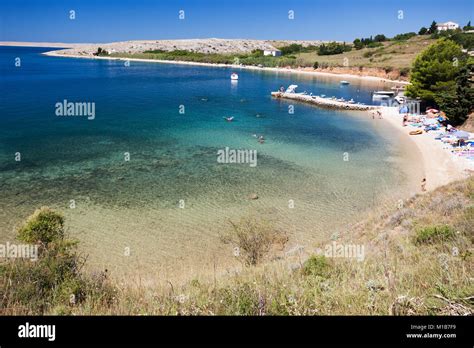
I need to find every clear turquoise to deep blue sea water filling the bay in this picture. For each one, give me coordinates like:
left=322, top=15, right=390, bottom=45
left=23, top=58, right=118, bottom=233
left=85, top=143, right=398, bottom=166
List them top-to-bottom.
left=0, top=47, right=416, bottom=280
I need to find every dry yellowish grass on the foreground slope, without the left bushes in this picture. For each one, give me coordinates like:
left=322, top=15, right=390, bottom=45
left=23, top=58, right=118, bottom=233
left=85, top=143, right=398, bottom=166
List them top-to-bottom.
left=0, top=177, right=474, bottom=315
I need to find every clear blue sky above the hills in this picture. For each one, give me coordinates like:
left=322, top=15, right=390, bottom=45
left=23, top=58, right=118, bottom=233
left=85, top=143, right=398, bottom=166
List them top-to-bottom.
left=0, top=0, right=474, bottom=43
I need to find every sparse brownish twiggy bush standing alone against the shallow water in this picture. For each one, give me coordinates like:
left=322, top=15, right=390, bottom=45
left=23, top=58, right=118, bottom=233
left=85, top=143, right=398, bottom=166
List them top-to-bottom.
left=220, top=219, right=288, bottom=266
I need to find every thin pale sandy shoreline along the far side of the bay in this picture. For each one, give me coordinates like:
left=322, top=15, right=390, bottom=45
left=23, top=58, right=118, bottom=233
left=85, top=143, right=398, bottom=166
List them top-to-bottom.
left=42, top=51, right=410, bottom=85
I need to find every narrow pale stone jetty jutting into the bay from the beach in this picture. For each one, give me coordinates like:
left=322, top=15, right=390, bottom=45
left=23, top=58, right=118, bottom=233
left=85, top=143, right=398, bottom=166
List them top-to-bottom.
left=272, top=91, right=380, bottom=111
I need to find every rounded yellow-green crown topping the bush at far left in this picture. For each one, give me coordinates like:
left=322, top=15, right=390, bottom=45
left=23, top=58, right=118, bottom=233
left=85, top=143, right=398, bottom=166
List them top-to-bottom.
left=18, top=207, right=64, bottom=245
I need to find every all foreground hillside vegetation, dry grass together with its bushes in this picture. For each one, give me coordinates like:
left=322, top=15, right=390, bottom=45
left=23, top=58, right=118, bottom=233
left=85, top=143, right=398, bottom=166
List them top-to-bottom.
left=0, top=177, right=474, bottom=315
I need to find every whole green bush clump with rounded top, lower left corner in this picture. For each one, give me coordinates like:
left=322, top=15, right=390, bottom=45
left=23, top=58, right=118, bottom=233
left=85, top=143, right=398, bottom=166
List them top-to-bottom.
left=0, top=207, right=114, bottom=315
